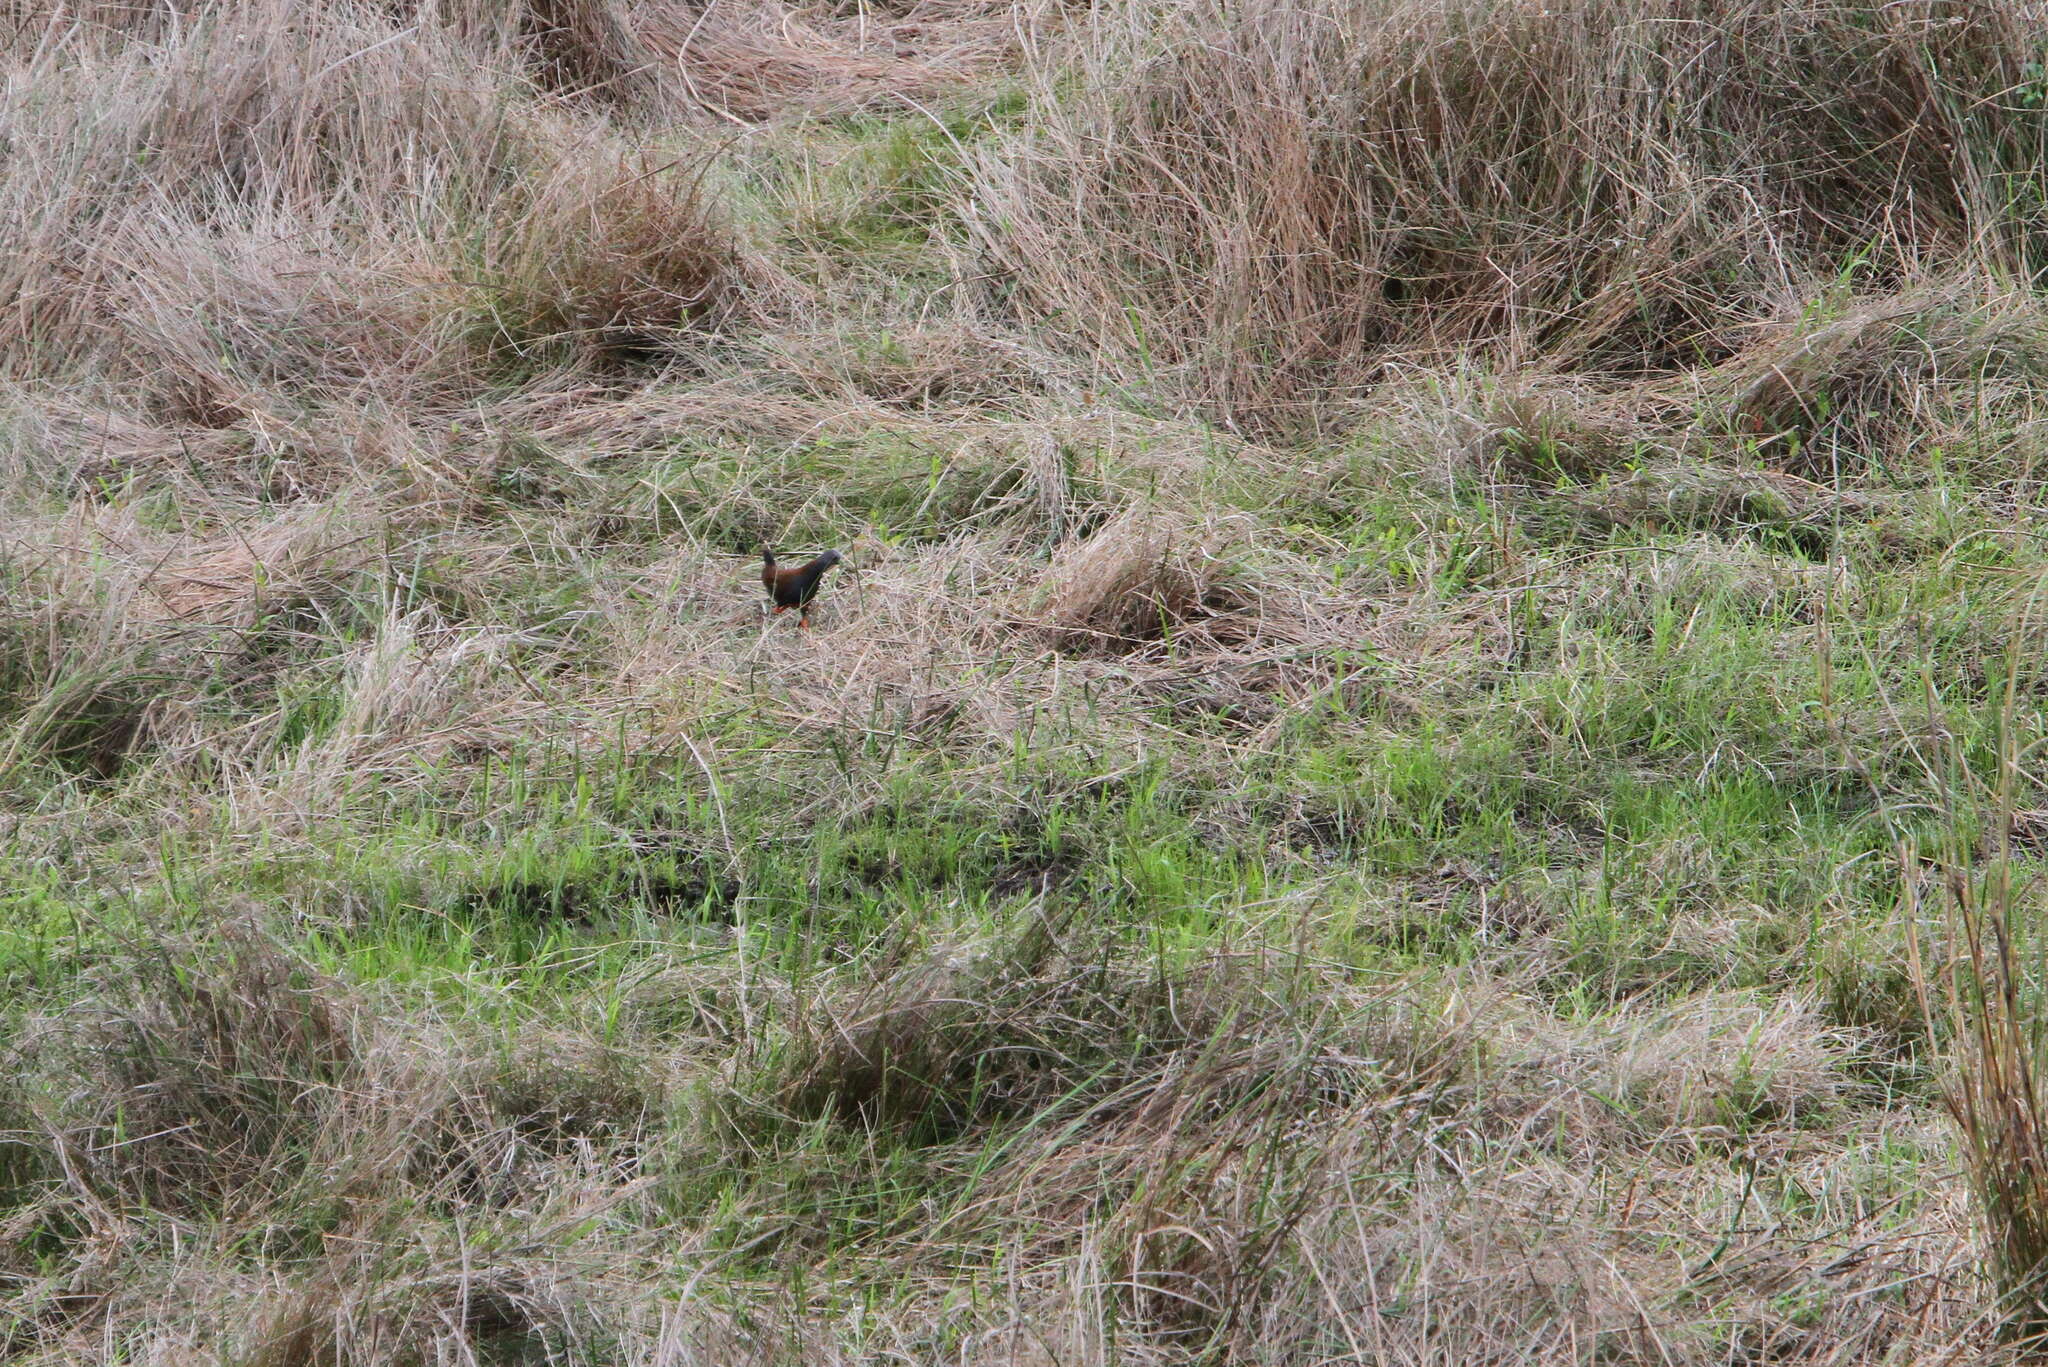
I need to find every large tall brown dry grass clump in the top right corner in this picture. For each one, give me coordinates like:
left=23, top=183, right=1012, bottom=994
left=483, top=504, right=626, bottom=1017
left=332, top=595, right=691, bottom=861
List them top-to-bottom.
left=971, top=0, right=2048, bottom=422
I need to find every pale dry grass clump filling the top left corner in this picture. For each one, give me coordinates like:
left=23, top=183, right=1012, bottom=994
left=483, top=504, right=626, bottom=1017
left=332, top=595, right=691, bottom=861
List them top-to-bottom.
left=0, top=4, right=761, bottom=428
